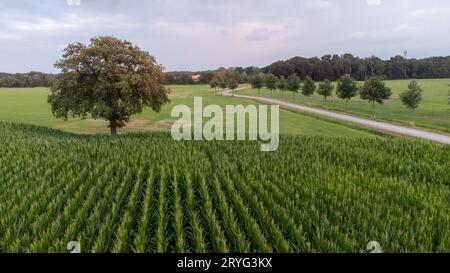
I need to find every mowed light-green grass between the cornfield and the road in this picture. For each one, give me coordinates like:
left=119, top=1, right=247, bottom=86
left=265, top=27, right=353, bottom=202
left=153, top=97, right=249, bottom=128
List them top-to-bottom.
left=0, top=85, right=374, bottom=137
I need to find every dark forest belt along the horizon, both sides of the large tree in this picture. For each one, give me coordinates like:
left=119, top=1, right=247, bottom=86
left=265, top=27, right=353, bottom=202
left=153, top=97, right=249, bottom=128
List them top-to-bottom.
left=0, top=54, right=450, bottom=87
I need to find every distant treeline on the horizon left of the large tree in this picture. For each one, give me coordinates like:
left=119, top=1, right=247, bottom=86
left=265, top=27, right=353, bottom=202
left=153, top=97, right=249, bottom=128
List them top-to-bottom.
left=0, top=72, right=56, bottom=88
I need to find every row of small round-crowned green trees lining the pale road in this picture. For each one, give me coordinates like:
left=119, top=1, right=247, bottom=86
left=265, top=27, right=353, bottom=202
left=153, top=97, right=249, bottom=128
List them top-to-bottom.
left=210, top=73, right=423, bottom=115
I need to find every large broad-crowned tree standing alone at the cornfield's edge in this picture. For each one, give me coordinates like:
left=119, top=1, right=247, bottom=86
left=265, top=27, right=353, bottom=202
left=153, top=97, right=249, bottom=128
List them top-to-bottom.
left=48, top=36, right=169, bottom=135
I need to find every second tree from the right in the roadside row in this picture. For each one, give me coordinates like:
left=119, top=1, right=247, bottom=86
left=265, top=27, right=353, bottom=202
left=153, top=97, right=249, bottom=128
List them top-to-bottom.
left=360, top=77, right=392, bottom=117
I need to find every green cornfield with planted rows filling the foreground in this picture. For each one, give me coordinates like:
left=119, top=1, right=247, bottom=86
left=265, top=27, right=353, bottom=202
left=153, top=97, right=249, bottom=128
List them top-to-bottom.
left=0, top=123, right=450, bottom=253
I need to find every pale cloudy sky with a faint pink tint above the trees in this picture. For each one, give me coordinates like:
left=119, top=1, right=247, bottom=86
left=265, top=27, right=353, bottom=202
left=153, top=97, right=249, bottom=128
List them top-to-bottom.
left=0, top=0, right=450, bottom=72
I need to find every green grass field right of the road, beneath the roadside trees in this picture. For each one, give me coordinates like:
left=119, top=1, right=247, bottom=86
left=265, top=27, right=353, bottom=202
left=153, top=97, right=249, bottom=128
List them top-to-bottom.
left=239, top=79, right=450, bottom=132
